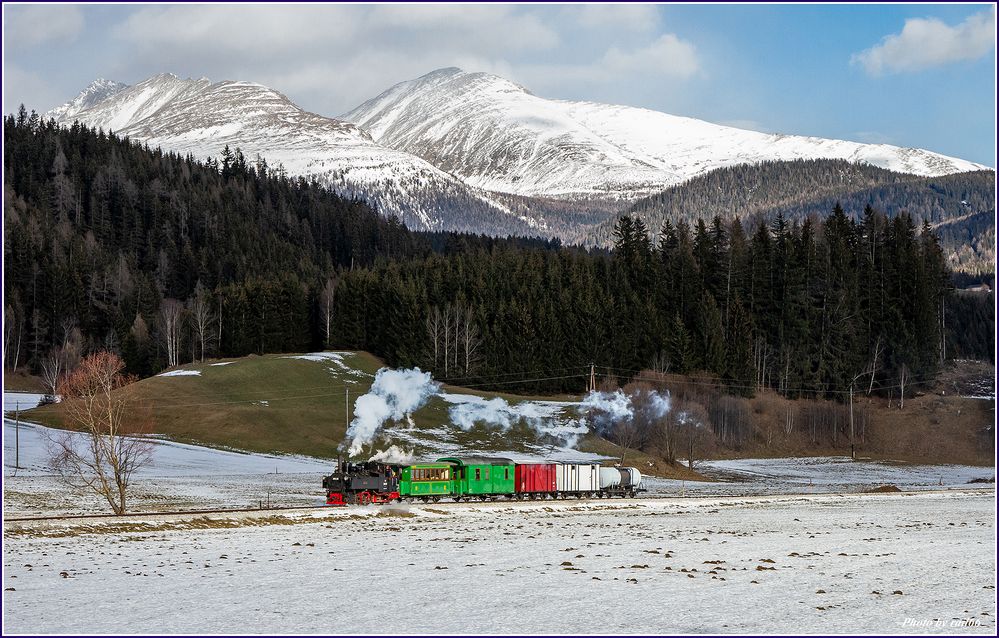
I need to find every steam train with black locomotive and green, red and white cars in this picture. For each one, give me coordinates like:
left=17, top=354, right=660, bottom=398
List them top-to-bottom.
left=323, top=456, right=645, bottom=505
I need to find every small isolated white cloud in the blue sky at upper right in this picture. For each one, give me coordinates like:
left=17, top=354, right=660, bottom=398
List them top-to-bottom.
left=850, top=7, right=996, bottom=75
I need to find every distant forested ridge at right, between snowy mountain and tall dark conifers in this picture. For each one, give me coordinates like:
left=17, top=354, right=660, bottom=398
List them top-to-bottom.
left=590, top=160, right=996, bottom=275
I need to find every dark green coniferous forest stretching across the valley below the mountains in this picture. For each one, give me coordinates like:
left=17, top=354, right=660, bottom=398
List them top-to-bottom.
left=3, top=110, right=994, bottom=397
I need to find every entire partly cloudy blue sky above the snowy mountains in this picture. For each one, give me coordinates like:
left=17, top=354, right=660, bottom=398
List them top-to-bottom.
left=3, top=4, right=996, bottom=167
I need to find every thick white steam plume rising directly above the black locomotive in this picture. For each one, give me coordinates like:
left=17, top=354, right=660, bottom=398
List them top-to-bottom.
left=344, top=368, right=440, bottom=456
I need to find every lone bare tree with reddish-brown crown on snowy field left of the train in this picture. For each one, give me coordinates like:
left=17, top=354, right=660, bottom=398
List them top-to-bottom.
left=51, top=351, right=152, bottom=515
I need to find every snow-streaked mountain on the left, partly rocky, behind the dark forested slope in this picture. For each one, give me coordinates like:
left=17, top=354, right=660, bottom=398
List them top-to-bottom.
left=46, top=74, right=535, bottom=234
